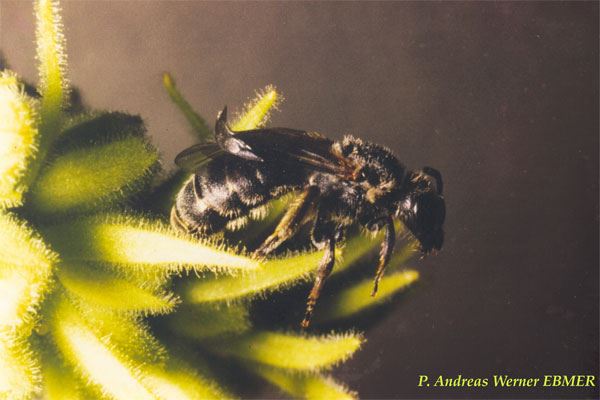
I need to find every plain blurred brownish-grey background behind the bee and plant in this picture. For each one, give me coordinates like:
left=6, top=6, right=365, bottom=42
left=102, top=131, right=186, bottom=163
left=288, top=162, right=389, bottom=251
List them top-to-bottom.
left=0, top=1, right=599, bottom=398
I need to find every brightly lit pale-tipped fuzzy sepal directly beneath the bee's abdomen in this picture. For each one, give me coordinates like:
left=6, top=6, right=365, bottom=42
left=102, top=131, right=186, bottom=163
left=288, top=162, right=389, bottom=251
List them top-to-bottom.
left=43, top=214, right=258, bottom=272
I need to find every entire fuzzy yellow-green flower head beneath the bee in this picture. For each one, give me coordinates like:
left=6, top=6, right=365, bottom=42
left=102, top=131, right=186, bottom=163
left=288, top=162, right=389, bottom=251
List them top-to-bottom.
left=0, top=0, right=418, bottom=399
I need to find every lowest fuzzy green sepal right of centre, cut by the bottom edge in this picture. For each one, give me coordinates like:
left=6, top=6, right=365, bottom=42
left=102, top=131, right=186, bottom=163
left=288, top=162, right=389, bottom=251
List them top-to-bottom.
left=252, top=366, right=357, bottom=400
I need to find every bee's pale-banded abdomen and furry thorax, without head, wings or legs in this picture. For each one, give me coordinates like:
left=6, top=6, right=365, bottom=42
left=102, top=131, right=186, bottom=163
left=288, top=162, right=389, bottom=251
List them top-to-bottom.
left=171, top=133, right=409, bottom=243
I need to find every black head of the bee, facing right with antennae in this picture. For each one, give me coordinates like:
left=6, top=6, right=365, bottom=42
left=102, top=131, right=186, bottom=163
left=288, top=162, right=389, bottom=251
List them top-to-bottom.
left=396, top=167, right=446, bottom=254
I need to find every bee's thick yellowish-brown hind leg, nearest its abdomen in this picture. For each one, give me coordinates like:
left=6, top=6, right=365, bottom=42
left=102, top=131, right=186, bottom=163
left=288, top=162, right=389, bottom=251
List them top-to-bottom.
left=254, top=186, right=319, bottom=258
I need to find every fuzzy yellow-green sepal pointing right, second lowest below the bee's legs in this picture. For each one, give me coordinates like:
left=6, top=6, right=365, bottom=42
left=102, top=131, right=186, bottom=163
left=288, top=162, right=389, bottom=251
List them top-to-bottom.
left=210, top=332, right=364, bottom=371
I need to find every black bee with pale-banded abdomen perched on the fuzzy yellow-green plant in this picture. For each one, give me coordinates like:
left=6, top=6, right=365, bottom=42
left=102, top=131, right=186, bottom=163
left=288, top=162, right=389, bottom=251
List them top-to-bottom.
left=171, top=107, right=446, bottom=328
